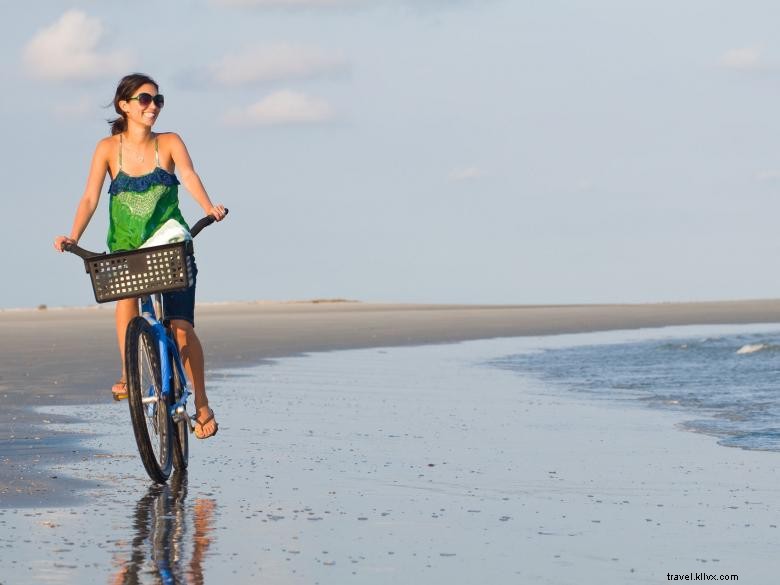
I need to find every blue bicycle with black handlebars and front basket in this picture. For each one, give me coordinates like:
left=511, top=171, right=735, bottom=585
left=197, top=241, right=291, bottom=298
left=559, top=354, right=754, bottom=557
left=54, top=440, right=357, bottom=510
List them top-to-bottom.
left=63, top=210, right=228, bottom=484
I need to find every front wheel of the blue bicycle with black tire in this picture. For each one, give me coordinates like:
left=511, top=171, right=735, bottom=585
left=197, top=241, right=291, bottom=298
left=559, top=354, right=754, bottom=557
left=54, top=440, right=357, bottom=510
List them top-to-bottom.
left=125, top=317, right=173, bottom=483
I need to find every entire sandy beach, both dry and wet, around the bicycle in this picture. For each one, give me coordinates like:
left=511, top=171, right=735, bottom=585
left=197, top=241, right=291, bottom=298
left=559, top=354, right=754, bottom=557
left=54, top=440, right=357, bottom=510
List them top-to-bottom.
left=0, top=300, right=780, bottom=585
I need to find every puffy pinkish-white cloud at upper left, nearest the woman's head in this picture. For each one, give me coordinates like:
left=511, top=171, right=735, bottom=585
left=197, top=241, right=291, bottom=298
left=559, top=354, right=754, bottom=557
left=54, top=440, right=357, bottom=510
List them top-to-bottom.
left=23, top=10, right=132, bottom=81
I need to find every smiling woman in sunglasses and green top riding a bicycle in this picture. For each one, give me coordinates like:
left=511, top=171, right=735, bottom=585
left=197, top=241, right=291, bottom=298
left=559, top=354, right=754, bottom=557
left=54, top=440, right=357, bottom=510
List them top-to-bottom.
left=54, top=73, right=225, bottom=439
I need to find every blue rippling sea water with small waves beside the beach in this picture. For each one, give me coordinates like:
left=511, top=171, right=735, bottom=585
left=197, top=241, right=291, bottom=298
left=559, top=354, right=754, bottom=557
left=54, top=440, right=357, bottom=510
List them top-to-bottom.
left=487, top=325, right=780, bottom=451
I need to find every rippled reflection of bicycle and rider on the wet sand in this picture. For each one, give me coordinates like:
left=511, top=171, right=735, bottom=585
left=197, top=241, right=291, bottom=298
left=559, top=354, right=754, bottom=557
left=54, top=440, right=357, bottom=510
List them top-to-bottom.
left=109, top=473, right=216, bottom=585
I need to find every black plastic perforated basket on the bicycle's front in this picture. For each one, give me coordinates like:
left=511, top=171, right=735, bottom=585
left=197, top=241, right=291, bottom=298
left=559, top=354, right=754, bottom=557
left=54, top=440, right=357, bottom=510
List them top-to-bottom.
left=84, top=242, right=192, bottom=303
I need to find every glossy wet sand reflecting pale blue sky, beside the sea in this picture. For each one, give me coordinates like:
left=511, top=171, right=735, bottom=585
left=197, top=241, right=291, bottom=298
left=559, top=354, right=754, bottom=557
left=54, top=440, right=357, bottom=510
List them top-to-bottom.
left=0, top=332, right=780, bottom=585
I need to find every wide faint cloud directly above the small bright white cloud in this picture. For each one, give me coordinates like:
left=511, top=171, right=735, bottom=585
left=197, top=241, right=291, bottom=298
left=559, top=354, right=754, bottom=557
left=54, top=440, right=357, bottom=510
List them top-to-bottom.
left=207, top=44, right=348, bottom=86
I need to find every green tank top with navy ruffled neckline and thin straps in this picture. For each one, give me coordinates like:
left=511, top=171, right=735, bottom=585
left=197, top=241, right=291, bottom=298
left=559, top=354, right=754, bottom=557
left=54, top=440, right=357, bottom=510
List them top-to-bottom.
left=107, top=134, right=190, bottom=252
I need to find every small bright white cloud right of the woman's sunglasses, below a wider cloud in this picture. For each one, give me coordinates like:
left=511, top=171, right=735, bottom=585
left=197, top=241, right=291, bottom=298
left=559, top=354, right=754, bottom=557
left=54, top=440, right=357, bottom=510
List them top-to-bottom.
left=224, top=90, right=335, bottom=126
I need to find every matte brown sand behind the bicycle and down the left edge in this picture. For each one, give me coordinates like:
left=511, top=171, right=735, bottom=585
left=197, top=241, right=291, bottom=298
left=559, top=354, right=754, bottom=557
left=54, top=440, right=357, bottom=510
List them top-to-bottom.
left=0, top=300, right=780, bottom=508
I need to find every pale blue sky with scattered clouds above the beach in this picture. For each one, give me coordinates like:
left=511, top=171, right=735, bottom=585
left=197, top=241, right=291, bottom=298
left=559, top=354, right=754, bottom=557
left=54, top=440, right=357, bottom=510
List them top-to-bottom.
left=0, top=0, right=780, bottom=308
